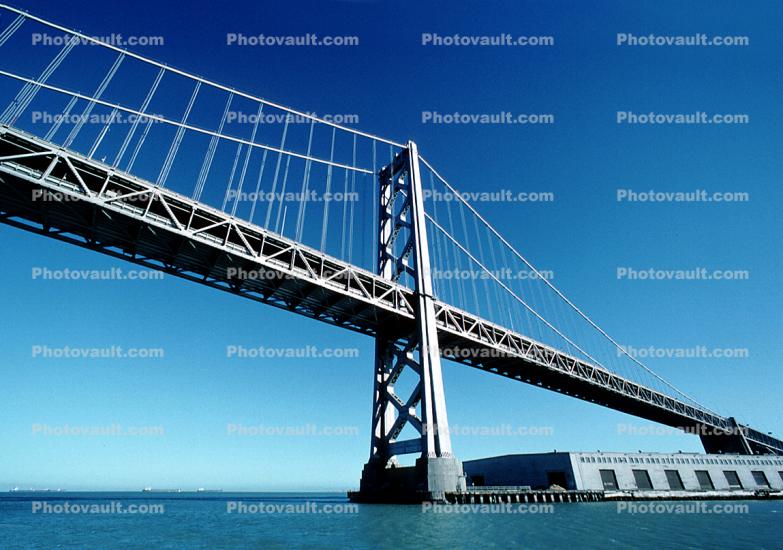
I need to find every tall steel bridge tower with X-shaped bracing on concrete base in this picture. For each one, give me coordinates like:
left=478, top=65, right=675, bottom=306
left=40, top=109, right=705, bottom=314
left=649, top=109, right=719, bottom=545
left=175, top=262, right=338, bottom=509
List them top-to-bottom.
left=355, top=141, right=465, bottom=502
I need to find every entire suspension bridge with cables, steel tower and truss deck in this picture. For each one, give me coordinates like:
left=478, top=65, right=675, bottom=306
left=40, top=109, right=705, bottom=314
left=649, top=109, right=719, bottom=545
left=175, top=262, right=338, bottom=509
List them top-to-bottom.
left=0, top=5, right=783, bottom=500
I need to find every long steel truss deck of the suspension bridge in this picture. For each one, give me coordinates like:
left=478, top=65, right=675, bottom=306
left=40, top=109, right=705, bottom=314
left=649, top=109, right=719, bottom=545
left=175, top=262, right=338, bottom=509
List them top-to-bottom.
left=0, top=127, right=783, bottom=453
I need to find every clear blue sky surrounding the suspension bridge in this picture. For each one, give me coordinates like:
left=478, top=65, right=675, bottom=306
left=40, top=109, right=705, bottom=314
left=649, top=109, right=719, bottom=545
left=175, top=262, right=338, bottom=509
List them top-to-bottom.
left=0, top=0, right=783, bottom=490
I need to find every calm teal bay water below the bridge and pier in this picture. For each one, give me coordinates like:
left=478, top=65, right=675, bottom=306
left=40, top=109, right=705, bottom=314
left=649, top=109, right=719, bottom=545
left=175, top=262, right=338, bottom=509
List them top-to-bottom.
left=0, top=493, right=783, bottom=550
